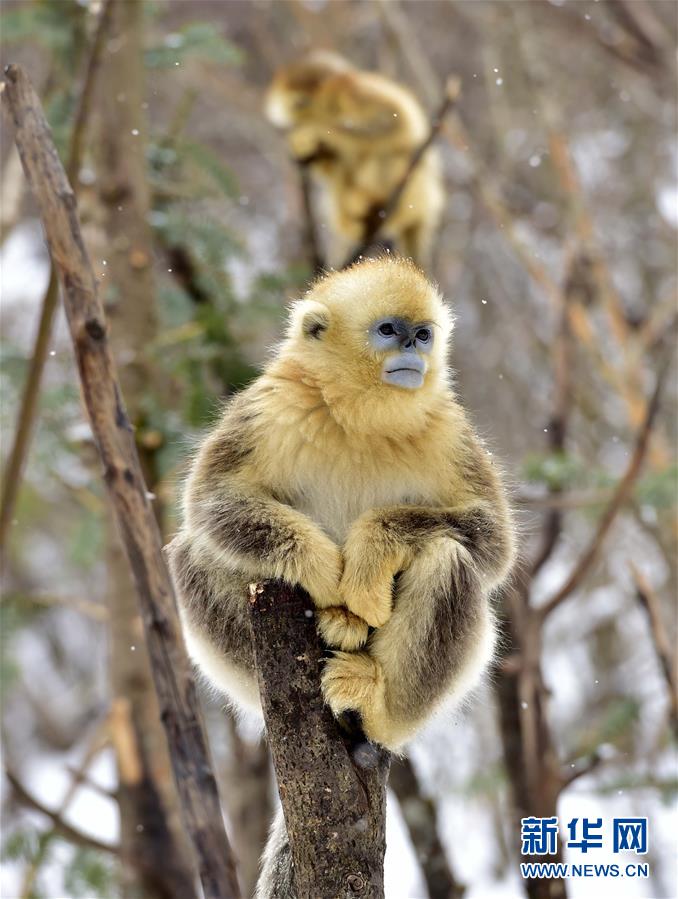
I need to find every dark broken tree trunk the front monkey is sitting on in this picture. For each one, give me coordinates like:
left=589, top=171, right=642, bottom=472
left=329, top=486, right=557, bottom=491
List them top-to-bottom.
left=250, top=582, right=389, bottom=899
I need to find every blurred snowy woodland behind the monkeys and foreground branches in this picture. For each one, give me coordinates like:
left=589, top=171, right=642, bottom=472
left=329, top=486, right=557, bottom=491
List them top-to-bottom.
left=0, top=0, right=678, bottom=899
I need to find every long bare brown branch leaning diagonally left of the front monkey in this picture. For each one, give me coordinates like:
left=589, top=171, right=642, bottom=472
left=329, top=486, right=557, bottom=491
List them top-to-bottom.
left=2, top=65, right=239, bottom=899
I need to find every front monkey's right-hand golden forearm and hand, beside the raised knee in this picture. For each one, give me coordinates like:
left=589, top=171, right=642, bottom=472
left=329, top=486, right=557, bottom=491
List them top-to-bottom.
left=339, top=512, right=410, bottom=627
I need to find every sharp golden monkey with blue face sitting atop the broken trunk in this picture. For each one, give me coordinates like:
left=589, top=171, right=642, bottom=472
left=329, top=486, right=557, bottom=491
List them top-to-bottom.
left=169, top=257, right=513, bottom=899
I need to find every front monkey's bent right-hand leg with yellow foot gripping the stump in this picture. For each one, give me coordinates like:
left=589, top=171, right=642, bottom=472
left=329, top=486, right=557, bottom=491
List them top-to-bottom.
left=323, top=537, right=494, bottom=750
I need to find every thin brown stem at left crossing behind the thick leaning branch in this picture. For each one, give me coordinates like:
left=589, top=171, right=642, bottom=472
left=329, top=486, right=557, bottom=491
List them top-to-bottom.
left=0, top=0, right=112, bottom=557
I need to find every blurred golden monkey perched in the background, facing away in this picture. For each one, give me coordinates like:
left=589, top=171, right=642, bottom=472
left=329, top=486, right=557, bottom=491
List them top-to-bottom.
left=266, top=51, right=444, bottom=269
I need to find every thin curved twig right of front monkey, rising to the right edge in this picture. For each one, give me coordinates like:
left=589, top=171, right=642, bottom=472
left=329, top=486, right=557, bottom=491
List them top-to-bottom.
left=538, top=357, right=670, bottom=619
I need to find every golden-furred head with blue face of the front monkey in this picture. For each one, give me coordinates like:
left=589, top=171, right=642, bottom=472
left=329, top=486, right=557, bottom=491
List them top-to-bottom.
left=283, top=256, right=452, bottom=424
